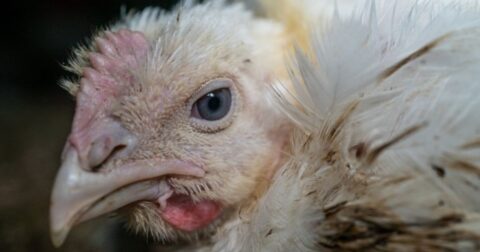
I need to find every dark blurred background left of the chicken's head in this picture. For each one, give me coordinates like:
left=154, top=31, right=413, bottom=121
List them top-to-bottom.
left=0, top=0, right=182, bottom=252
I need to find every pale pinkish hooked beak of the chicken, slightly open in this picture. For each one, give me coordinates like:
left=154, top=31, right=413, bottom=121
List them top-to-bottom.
left=50, top=146, right=204, bottom=247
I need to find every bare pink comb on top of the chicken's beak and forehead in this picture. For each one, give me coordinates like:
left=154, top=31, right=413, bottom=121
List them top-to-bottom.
left=69, top=29, right=149, bottom=167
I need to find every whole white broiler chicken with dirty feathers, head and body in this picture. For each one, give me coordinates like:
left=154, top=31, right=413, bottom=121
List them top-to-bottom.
left=50, top=0, right=480, bottom=251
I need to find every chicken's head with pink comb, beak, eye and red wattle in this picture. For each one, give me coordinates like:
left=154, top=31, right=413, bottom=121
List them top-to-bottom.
left=51, top=1, right=289, bottom=244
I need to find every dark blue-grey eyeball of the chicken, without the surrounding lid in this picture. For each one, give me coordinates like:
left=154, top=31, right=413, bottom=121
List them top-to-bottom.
left=192, top=88, right=232, bottom=121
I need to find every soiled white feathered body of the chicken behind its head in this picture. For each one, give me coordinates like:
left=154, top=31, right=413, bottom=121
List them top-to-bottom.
left=209, top=1, right=480, bottom=251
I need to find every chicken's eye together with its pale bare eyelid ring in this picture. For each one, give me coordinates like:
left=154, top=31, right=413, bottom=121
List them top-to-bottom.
left=188, top=78, right=237, bottom=133
